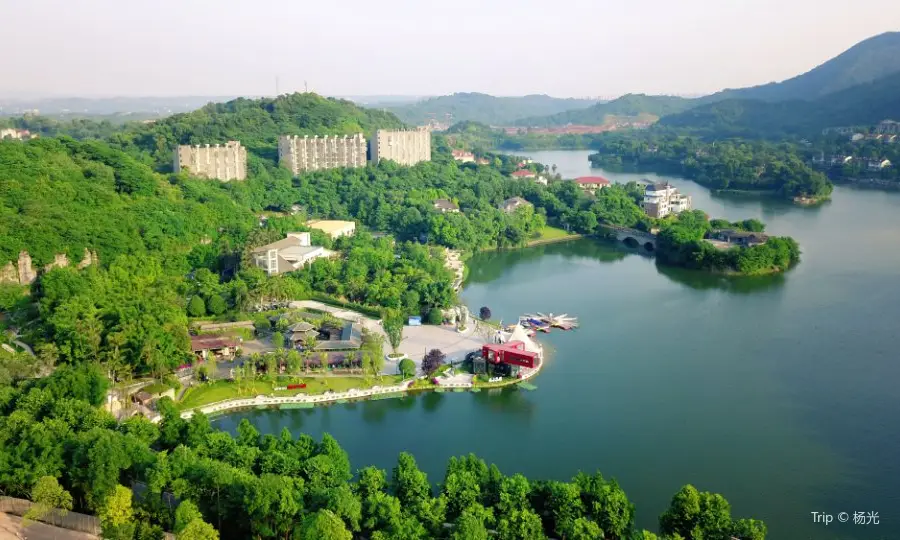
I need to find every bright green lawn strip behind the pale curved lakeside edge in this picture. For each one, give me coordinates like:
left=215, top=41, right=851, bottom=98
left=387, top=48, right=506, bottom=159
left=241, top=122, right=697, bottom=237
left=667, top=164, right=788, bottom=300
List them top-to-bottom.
left=178, top=375, right=403, bottom=410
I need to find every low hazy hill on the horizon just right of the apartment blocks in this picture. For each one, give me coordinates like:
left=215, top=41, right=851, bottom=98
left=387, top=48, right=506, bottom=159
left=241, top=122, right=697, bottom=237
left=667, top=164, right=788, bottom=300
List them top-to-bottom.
left=389, top=92, right=597, bottom=126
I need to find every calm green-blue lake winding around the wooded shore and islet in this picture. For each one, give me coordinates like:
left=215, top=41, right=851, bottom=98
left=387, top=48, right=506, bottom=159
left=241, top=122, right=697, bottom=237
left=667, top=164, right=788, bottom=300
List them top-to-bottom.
left=218, top=151, right=900, bottom=540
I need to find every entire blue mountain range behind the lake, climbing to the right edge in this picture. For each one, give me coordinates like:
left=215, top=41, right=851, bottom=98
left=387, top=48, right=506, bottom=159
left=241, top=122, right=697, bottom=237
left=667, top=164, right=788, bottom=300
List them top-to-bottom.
left=517, top=32, right=900, bottom=135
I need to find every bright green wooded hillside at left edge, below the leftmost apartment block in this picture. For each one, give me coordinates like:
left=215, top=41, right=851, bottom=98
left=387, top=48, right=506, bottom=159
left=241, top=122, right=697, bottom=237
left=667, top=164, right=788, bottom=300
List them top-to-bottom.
left=0, top=138, right=253, bottom=266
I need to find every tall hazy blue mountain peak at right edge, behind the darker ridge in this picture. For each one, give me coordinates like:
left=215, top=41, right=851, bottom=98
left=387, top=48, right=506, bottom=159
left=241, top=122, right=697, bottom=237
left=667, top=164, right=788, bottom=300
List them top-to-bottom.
left=701, top=32, right=900, bottom=102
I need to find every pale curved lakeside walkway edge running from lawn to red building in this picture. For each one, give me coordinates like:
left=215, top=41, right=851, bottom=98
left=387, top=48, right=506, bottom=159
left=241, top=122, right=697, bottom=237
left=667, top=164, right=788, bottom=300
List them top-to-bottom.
left=176, top=353, right=544, bottom=422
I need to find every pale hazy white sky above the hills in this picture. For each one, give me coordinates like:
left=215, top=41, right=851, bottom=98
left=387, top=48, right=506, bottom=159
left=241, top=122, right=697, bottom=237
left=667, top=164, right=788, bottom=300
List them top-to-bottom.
left=0, top=0, right=900, bottom=97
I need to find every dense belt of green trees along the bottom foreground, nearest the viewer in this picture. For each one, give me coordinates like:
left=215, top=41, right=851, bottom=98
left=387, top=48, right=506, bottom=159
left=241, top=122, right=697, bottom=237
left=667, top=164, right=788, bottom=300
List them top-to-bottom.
left=0, top=365, right=766, bottom=540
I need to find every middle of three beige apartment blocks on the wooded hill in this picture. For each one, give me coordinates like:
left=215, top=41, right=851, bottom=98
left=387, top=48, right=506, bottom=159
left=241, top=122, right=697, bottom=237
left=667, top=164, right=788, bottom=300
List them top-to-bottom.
left=278, top=133, right=366, bottom=175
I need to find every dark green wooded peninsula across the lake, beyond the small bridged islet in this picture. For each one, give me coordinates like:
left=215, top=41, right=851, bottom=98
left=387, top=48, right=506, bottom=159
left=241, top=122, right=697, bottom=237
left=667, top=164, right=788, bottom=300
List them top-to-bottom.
left=590, top=133, right=833, bottom=198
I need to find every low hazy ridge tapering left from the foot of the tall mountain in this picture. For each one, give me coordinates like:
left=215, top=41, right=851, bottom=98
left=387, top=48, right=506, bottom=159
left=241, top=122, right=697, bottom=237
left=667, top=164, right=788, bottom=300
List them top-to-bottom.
left=516, top=94, right=694, bottom=127
